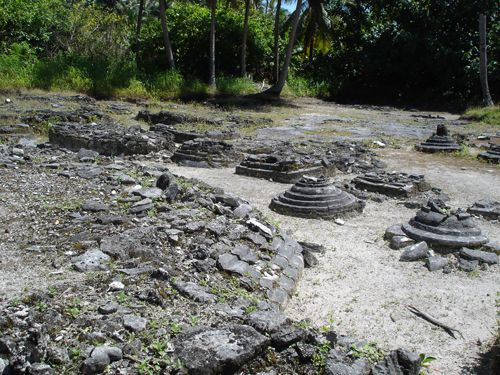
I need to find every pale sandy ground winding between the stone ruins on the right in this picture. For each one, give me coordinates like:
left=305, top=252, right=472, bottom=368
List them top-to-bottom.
left=171, top=150, right=500, bottom=375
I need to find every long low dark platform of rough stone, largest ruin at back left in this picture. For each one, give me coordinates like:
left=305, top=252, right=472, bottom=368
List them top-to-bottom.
left=49, top=122, right=174, bottom=156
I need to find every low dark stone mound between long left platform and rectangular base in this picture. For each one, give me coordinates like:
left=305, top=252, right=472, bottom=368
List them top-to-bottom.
left=172, top=138, right=239, bottom=168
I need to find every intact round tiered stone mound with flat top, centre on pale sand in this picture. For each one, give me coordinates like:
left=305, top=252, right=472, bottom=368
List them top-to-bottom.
left=269, top=176, right=364, bottom=219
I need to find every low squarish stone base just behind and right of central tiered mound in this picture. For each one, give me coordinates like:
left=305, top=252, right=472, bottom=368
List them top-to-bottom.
left=352, top=171, right=431, bottom=198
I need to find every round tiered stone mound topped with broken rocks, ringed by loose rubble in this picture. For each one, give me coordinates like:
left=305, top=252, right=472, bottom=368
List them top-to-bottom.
left=401, top=199, right=488, bottom=250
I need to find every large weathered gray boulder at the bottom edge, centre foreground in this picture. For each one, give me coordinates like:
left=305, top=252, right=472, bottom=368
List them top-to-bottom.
left=174, top=325, right=269, bottom=375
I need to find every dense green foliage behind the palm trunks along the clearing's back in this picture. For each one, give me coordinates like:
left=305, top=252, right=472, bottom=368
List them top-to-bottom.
left=0, top=0, right=500, bottom=106
